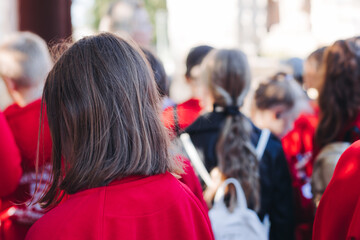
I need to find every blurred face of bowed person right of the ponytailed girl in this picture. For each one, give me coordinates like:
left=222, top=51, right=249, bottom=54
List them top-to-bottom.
left=251, top=105, right=294, bottom=138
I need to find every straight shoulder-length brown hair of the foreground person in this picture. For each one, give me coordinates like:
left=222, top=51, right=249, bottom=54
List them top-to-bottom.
left=40, top=33, right=177, bottom=207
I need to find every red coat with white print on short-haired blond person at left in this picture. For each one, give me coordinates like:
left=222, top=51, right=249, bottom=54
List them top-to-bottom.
left=1, top=99, right=52, bottom=240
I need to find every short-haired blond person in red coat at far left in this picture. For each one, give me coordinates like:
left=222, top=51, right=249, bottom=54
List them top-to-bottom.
left=0, top=32, right=52, bottom=240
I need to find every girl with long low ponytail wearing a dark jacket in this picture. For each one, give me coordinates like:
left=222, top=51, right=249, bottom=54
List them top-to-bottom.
left=186, top=50, right=294, bottom=240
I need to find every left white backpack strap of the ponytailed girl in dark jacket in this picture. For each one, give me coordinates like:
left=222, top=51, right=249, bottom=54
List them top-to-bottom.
left=180, top=133, right=214, bottom=187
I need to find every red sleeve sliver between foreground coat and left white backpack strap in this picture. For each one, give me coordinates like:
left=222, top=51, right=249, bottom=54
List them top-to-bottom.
left=180, top=157, right=208, bottom=210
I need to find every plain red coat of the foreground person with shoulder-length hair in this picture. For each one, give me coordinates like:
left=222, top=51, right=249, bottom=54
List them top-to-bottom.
left=26, top=173, right=214, bottom=240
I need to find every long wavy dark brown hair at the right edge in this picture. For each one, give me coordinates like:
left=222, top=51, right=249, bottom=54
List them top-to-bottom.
left=315, top=38, right=360, bottom=148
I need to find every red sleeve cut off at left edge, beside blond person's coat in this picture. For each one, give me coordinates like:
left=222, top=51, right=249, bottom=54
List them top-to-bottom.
left=0, top=112, right=22, bottom=197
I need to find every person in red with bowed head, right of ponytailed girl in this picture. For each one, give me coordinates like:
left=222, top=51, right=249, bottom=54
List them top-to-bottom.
left=251, top=73, right=317, bottom=182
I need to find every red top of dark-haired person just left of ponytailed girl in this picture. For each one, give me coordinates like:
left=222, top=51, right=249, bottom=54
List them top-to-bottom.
left=162, top=98, right=202, bottom=133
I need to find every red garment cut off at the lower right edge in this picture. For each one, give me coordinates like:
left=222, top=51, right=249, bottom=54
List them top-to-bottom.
left=313, top=141, right=360, bottom=240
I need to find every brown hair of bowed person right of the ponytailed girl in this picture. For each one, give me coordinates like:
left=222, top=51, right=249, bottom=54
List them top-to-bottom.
left=254, top=72, right=296, bottom=110
